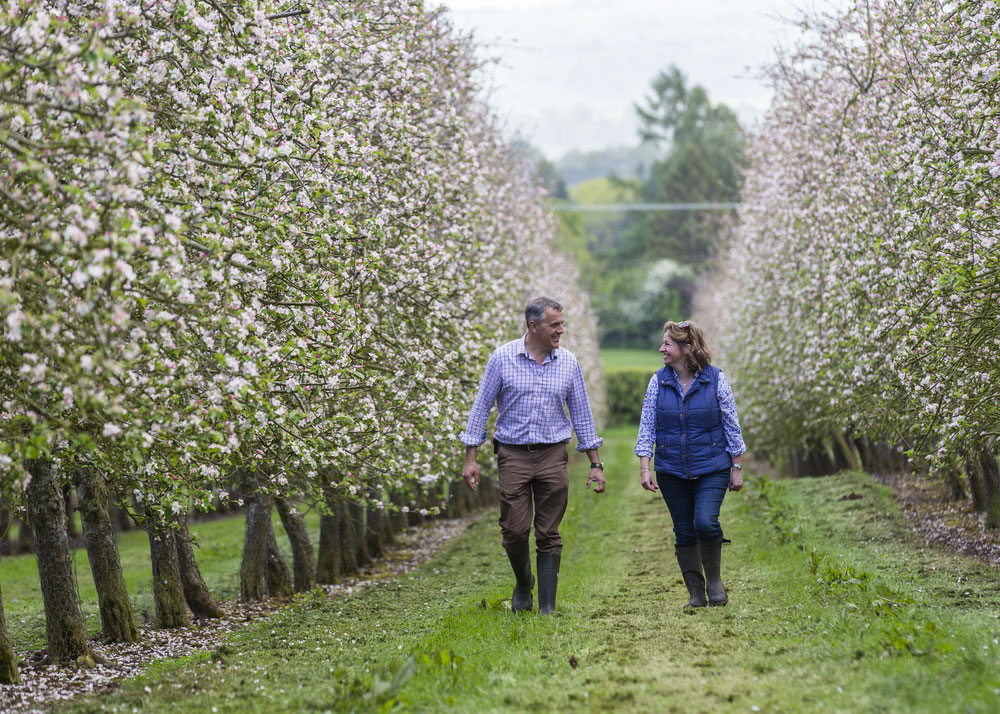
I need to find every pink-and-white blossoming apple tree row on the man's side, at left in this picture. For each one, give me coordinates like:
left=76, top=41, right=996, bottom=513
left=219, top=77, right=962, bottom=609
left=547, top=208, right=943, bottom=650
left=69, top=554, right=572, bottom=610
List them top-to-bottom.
left=0, top=0, right=600, bottom=676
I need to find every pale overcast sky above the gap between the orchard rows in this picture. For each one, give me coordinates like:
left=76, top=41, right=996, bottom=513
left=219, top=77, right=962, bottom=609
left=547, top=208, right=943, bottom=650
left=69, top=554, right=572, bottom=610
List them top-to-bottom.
left=438, top=0, right=837, bottom=159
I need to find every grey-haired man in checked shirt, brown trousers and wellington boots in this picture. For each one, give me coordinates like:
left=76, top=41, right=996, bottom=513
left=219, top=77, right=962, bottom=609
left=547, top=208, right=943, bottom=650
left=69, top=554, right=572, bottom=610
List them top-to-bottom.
left=461, top=297, right=604, bottom=614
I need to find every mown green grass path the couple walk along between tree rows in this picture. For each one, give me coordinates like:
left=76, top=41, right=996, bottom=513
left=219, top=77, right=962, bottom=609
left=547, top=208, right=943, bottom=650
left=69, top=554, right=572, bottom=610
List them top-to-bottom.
left=60, top=430, right=1000, bottom=713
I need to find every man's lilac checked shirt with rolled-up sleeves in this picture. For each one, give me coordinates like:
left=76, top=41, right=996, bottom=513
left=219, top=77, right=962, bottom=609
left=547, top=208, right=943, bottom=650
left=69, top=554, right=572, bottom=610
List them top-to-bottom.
left=459, top=337, right=604, bottom=451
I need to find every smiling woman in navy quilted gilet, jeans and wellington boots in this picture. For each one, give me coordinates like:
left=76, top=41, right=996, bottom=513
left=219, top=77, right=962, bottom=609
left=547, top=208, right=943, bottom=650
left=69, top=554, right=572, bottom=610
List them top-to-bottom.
left=635, top=322, right=746, bottom=607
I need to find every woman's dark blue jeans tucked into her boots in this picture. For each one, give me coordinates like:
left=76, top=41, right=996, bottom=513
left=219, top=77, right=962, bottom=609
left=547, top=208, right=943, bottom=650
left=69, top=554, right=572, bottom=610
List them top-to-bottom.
left=656, top=469, right=729, bottom=545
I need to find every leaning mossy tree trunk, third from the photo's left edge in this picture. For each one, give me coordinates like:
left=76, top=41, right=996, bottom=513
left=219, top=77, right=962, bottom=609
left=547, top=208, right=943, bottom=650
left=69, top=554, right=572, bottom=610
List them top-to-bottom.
left=77, top=468, right=139, bottom=643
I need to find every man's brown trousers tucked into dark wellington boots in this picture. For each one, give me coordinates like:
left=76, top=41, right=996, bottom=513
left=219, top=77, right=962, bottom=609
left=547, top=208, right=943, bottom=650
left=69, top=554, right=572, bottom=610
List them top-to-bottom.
left=497, top=444, right=569, bottom=553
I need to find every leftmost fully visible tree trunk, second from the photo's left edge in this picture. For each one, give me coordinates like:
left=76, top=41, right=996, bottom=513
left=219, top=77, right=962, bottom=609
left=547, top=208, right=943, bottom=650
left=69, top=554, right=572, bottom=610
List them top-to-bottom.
left=25, top=459, right=91, bottom=664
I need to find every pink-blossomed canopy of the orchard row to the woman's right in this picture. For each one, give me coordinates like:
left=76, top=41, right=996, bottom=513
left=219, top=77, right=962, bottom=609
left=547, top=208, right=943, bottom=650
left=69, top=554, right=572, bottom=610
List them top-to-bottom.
left=703, top=0, right=1000, bottom=496
